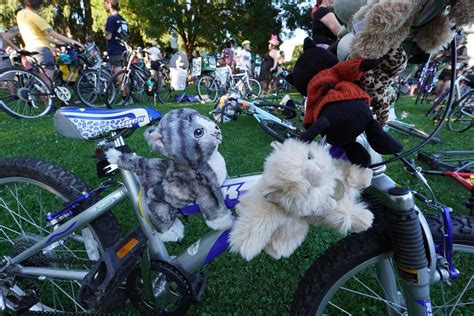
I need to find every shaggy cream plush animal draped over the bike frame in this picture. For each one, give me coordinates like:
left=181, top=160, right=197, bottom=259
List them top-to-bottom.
left=229, top=139, right=373, bottom=260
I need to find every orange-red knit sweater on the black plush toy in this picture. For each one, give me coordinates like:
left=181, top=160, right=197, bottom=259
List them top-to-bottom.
left=304, top=58, right=370, bottom=124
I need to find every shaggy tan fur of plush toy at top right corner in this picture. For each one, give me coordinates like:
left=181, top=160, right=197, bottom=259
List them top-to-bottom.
left=344, top=0, right=474, bottom=58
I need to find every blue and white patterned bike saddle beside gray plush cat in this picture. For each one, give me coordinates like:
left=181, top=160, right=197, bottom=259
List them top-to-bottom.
left=54, top=107, right=162, bottom=140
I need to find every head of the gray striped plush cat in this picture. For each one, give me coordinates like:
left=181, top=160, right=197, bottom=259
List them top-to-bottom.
left=144, top=109, right=222, bottom=168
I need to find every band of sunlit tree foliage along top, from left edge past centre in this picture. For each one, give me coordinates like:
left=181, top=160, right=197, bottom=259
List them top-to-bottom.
left=0, top=0, right=309, bottom=54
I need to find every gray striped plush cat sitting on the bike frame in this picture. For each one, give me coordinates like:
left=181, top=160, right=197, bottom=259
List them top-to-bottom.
left=106, top=109, right=233, bottom=241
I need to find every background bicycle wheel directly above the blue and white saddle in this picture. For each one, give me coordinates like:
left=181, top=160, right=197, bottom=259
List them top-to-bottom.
left=74, top=69, right=117, bottom=108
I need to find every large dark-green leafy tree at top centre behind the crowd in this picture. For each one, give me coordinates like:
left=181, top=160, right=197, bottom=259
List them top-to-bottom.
left=125, top=0, right=281, bottom=55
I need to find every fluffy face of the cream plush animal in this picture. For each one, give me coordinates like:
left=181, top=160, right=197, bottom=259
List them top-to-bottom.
left=265, top=139, right=334, bottom=189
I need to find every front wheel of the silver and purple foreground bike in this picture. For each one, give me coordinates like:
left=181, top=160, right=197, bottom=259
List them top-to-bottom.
left=291, top=216, right=474, bottom=315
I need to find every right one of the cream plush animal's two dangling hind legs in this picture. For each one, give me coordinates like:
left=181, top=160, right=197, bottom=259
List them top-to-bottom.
left=265, top=218, right=308, bottom=260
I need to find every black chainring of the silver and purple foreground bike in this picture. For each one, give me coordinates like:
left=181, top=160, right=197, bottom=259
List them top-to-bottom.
left=127, top=261, right=193, bottom=315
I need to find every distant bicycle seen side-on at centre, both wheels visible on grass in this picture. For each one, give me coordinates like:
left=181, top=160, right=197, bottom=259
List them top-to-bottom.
left=197, top=66, right=262, bottom=102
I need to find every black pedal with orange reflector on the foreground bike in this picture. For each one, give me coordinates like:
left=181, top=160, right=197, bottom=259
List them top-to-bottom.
left=78, top=228, right=147, bottom=312
